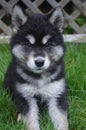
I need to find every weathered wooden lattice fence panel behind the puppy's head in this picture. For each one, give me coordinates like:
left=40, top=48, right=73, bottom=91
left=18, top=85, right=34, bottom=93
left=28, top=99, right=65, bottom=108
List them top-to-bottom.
left=0, top=0, right=86, bottom=35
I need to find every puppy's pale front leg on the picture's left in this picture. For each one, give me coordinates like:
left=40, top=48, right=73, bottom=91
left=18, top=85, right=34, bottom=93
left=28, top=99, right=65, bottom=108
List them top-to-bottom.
left=23, top=99, right=40, bottom=130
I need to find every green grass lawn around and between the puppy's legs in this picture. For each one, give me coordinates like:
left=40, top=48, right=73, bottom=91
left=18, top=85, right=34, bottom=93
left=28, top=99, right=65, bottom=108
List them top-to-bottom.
left=0, top=43, right=86, bottom=130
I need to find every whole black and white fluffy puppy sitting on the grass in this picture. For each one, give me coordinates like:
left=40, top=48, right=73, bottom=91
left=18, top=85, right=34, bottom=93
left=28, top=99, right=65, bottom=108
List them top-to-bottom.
left=4, top=6, right=68, bottom=130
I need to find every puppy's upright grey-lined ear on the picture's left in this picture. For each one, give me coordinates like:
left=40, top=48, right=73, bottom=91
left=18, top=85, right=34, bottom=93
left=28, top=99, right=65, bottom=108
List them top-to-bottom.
left=12, top=5, right=27, bottom=31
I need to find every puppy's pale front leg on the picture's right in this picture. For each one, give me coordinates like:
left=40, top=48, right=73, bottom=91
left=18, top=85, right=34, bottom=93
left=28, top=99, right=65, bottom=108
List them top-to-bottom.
left=48, top=98, right=68, bottom=130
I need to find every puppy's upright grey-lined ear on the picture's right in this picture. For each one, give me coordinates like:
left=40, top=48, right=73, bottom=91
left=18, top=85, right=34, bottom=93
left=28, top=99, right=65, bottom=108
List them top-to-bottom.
left=47, top=6, right=64, bottom=32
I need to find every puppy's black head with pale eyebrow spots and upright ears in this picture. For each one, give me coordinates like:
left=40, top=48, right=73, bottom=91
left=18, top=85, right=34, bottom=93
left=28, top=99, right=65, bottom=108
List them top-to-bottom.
left=11, top=6, right=64, bottom=73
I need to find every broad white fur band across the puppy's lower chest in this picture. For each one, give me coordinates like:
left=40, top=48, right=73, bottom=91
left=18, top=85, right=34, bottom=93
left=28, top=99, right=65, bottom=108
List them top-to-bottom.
left=16, top=79, right=65, bottom=98
